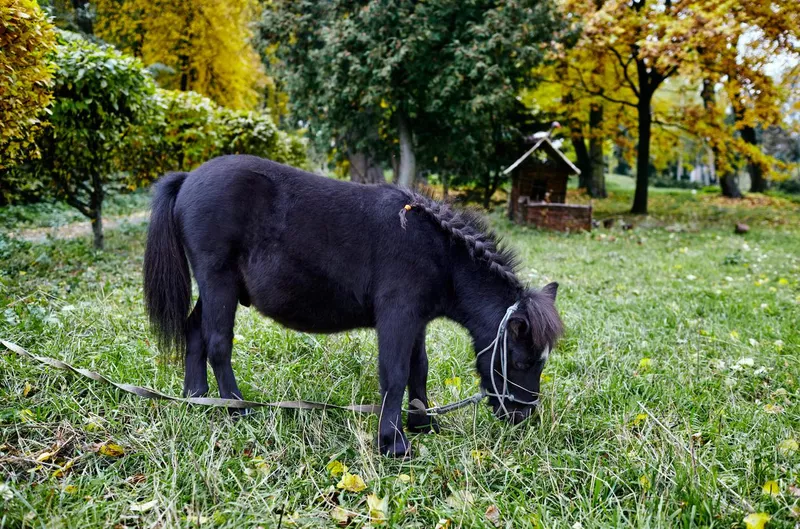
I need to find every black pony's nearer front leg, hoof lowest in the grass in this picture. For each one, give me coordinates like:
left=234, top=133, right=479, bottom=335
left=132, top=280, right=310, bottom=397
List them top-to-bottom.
left=377, top=311, right=422, bottom=457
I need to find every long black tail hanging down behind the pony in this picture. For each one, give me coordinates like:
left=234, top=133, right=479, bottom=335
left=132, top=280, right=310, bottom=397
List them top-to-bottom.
left=144, top=173, right=192, bottom=362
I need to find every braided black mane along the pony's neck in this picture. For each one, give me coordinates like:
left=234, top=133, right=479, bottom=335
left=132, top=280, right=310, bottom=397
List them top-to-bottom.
left=400, top=192, right=524, bottom=290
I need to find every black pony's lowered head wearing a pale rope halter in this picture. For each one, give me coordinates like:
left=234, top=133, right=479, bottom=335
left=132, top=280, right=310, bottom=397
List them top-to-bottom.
left=478, top=283, right=564, bottom=424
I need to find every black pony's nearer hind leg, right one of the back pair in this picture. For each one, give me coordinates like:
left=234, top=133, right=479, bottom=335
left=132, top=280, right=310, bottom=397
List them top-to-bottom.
left=197, top=271, right=242, bottom=406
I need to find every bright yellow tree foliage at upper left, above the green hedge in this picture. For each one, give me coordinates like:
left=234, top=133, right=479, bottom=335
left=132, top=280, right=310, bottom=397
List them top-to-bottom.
left=96, top=0, right=268, bottom=109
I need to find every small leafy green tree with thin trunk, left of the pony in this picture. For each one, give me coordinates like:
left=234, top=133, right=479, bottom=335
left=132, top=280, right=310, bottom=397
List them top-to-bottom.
left=11, top=32, right=156, bottom=248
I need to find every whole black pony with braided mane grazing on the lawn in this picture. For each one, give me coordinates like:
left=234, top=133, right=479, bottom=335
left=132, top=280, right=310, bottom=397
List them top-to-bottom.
left=144, top=155, right=562, bottom=456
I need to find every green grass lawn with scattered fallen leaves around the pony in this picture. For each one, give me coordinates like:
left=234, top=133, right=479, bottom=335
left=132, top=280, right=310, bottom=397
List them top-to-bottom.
left=0, top=188, right=800, bottom=529
